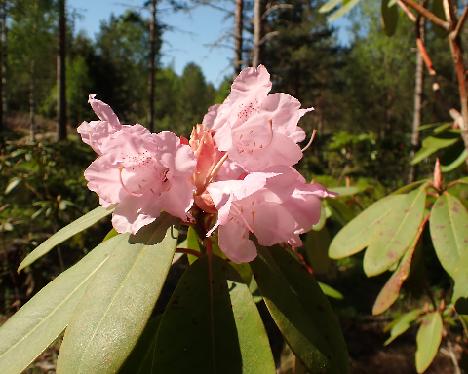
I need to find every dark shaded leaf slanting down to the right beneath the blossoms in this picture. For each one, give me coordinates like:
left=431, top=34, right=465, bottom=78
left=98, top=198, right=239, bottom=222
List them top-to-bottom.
left=251, top=246, right=348, bottom=373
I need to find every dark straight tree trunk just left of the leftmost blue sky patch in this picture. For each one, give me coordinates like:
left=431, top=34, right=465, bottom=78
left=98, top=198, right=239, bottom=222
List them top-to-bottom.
left=57, top=0, right=67, bottom=140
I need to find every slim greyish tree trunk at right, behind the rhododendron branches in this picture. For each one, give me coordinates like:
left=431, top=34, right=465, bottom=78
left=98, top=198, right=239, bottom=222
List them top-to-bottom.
left=408, top=17, right=425, bottom=183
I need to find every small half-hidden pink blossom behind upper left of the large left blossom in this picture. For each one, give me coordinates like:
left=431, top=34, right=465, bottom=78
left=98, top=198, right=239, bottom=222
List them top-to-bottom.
left=77, top=95, right=122, bottom=155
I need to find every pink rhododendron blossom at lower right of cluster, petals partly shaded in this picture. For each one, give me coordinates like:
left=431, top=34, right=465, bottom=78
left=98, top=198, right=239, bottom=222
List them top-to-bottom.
left=207, top=167, right=331, bottom=263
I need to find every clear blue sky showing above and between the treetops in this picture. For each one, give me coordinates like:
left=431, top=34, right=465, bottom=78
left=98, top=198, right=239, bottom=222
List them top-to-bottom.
left=68, top=0, right=348, bottom=85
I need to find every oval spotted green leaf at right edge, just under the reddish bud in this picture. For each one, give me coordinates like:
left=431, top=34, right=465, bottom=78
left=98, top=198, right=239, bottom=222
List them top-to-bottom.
left=429, top=193, right=468, bottom=278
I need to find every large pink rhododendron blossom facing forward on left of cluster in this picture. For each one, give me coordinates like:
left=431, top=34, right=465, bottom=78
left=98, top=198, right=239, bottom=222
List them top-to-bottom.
left=81, top=104, right=196, bottom=234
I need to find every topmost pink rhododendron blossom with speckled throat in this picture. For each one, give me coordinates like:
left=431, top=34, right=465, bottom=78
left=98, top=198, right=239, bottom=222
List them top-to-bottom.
left=203, top=65, right=313, bottom=171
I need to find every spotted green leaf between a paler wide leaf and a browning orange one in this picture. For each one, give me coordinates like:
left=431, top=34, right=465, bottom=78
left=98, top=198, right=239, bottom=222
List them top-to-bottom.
left=364, top=185, right=426, bottom=277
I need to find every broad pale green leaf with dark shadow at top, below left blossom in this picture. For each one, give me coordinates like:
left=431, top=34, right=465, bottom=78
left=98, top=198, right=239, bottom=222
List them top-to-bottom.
left=57, top=215, right=177, bottom=374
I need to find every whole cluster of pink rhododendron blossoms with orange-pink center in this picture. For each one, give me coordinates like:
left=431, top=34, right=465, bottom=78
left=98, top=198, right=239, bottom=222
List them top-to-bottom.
left=78, top=65, right=336, bottom=262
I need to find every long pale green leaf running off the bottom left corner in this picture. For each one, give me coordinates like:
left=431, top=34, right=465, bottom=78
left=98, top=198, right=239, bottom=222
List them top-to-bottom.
left=0, top=235, right=125, bottom=374
